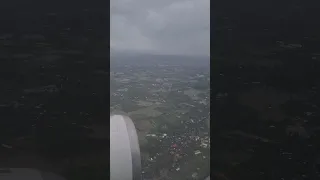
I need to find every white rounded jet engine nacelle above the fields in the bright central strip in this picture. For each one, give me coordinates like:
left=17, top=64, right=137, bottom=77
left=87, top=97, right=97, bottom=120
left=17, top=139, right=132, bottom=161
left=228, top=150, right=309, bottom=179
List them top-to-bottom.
left=110, top=115, right=141, bottom=180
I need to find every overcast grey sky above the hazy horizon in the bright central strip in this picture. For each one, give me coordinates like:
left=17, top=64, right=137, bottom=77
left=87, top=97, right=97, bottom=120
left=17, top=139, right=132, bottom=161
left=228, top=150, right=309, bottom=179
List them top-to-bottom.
left=110, top=0, right=210, bottom=55
